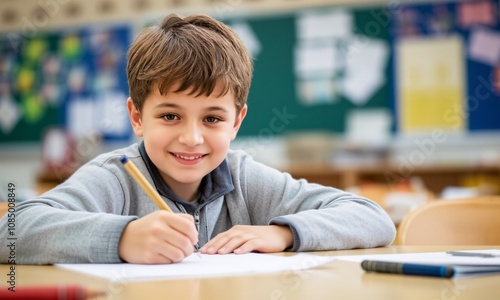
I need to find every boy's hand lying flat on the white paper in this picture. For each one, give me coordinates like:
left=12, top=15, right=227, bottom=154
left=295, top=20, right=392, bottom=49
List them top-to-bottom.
left=200, top=225, right=293, bottom=254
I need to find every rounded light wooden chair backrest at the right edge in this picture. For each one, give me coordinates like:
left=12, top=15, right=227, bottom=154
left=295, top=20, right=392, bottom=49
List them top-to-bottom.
left=397, top=196, right=500, bottom=245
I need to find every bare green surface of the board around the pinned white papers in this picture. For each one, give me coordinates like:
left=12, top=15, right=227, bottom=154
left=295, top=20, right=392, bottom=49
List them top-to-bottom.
left=222, top=7, right=390, bottom=136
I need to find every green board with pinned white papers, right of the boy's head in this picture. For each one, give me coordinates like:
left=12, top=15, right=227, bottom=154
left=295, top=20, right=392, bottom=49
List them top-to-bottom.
left=222, top=7, right=390, bottom=137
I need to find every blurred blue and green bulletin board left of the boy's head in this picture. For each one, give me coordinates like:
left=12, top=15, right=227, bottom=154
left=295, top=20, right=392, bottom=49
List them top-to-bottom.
left=0, top=25, right=132, bottom=144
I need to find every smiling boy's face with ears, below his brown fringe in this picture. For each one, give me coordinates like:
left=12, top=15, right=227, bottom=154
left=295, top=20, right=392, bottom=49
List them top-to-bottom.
left=127, top=82, right=247, bottom=201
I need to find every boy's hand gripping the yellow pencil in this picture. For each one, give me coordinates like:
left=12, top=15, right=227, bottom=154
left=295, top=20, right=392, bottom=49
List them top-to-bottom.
left=118, top=211, right=198, bottom=264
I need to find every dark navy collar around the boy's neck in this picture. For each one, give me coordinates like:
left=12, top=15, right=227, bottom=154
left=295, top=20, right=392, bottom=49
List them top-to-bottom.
left=139, top=142, right=234, bottom=213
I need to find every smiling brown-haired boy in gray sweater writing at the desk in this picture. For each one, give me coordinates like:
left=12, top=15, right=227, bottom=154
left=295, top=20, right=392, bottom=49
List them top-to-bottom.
left=0, top=15, right=395, bottom=264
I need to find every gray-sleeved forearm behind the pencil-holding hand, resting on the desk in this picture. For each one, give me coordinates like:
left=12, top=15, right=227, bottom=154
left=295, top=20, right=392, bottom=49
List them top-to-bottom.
left=0, top=205, right=135, bottom=264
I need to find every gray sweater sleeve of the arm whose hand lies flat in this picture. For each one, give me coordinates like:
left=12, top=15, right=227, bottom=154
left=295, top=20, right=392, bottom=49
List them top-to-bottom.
left=236, top=155, right=396, bottom=251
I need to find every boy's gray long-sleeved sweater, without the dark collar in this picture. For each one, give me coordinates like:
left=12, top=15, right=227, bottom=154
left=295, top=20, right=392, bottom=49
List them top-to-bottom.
left=0, top=143, right=396, bottom=264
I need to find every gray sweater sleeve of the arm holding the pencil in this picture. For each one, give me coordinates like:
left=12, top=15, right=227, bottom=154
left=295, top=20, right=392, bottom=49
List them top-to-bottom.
left=0, top=165, right=137, bottom=264
